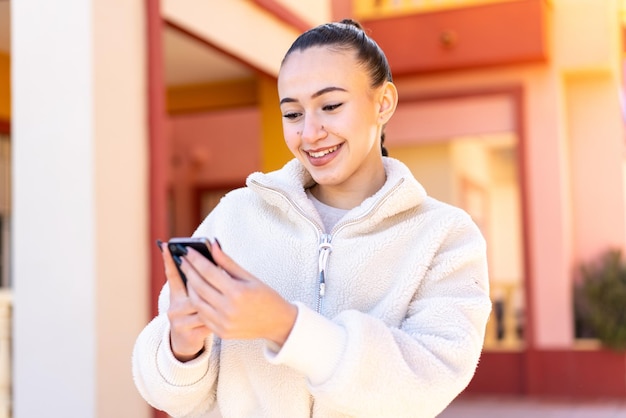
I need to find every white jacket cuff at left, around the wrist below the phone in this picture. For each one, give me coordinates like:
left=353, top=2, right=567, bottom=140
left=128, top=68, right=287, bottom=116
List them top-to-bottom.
left=156, top=326, right=213, bottom=387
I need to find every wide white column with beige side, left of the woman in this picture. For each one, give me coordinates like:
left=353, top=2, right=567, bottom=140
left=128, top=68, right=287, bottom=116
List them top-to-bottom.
left=11, top=0, right=150, bottom=418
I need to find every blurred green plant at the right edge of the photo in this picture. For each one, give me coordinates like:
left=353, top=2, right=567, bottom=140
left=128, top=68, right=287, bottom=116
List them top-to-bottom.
left=574, top=250, right=626, bottom=350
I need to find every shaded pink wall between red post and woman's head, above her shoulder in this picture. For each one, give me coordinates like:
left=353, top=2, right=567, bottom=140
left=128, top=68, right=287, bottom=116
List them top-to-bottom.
left=167, top=108, right=261, bottom=236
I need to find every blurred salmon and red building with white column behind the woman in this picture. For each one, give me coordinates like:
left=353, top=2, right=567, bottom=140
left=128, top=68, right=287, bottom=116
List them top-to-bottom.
left=0, top=0, right=626, bottom=418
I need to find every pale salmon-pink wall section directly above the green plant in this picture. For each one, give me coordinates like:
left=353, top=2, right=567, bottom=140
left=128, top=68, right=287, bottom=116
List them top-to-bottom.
left=566, top=75, right=626, bottom=262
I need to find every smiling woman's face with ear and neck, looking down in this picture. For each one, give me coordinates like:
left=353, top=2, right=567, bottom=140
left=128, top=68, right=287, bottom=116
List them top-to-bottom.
left=278, top=47, right=396, bottom=197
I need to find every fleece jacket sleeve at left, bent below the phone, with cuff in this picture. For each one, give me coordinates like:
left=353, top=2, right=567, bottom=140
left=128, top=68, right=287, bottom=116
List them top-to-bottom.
left=132, top=284, right=219, bottom=418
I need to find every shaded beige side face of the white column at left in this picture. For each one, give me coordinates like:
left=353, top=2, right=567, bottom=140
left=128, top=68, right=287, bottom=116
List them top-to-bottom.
left=92, top=0, right=153, bottom=418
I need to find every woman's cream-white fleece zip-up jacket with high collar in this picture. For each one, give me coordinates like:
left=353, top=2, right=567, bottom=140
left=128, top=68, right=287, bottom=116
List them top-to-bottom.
left=133, top=158, right=491, bottom=418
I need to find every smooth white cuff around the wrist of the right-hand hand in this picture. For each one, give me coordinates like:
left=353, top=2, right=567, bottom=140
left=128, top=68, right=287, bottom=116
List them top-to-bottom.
left=265, top=302, right=347, bottom=385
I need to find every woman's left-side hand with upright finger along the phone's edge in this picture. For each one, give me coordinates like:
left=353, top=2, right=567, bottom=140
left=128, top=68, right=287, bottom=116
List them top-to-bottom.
left=161, top=243, right=211, bottom=362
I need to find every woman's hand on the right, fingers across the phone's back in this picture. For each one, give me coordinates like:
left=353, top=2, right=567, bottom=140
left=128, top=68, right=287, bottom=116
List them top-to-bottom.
left=179, top=242, right=298, bottom=346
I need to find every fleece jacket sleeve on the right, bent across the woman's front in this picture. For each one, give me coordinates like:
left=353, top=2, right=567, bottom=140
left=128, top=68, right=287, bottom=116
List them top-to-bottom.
left=266, top=217, right=491, bottom=417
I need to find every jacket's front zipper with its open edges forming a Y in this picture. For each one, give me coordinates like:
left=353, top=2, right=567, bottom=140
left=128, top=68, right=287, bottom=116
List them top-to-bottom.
left=251, top=178, right=404, bottom=314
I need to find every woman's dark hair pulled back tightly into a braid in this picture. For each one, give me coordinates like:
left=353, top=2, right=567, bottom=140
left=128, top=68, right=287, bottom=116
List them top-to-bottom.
left=283, top=19, right=393, bottom=156
